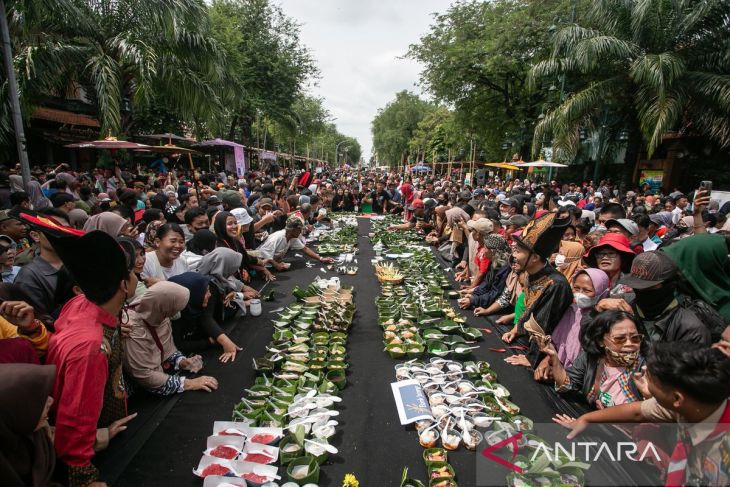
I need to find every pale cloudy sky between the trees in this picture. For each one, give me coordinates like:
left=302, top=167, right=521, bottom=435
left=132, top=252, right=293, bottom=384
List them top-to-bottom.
left=278, top=0, right=451, bottom=160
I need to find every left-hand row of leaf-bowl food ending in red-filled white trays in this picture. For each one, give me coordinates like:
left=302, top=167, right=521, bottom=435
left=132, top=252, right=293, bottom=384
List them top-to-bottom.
left=195, top=278, right=355, bottom=485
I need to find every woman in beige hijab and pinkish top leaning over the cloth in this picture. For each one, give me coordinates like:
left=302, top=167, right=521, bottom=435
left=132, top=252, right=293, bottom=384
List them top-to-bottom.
left=124, top=281, right=218, bottom=396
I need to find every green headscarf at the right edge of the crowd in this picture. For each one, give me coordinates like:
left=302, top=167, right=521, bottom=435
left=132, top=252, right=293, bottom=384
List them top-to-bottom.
left=662, top=233, right=730, bottom=323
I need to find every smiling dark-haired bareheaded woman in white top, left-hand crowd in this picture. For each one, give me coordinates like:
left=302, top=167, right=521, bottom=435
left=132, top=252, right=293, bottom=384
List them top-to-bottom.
left=141, top=223, right=188, bottom=287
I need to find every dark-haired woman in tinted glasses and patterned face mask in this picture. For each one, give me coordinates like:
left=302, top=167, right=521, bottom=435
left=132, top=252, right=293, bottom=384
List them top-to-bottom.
left=542, top=311, right=645, bottom=409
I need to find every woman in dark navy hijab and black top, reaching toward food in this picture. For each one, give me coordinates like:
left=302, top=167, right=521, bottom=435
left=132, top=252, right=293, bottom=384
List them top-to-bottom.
left=170, top=272, right=241, bottom=363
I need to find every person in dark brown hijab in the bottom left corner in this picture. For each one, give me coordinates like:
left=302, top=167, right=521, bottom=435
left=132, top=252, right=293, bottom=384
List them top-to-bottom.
left=0, top=364, right=56, bottom=487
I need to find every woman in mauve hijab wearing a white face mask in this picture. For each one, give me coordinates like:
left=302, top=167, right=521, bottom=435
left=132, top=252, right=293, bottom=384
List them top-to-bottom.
left=541, top=269, right=608, bottom=370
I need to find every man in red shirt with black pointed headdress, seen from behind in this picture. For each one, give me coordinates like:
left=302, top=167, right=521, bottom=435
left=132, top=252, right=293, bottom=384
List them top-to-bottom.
left=46, top=231, right=137, bottom=487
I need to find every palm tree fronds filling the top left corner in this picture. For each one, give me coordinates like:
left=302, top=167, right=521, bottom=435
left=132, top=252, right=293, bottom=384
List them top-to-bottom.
left=4, top=0, right=222, bottom=134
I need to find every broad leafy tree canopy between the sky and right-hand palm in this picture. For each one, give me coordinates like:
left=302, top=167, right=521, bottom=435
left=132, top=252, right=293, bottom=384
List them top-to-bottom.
left=408, top=0, right=570, bottom=159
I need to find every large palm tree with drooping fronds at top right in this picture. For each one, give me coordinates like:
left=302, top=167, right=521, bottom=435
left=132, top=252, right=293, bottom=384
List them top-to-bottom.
left=532, top=0, right=730, bottom=163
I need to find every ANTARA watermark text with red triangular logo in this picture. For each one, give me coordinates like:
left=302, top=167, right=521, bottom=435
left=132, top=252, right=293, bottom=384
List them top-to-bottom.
left=482, top=433, right=661, bottom=474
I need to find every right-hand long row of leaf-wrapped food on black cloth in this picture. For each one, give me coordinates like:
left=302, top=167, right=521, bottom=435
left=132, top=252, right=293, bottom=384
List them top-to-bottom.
left=371, top=217, right=587, bottom=487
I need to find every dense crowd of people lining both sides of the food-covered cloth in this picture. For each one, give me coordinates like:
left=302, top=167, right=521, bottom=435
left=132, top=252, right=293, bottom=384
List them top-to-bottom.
left=0, top=161, right=730, bottom=486
